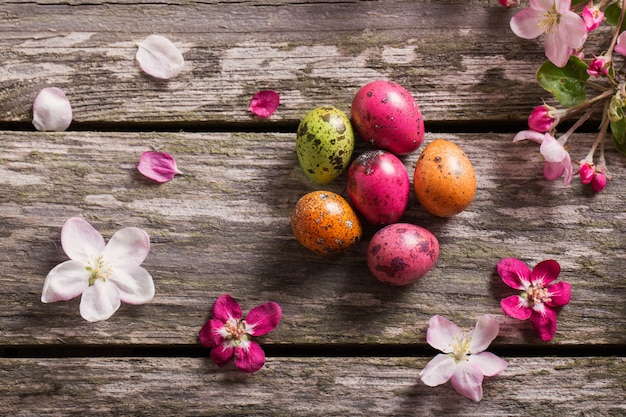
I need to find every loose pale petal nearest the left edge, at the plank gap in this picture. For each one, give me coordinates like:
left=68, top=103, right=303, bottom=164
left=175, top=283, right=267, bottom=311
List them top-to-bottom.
left=33, top=87, right=72, bottom=132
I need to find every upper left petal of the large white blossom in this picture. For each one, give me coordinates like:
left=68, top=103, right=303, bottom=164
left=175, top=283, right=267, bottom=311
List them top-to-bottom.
left=61, top=217, right=105, bottom=264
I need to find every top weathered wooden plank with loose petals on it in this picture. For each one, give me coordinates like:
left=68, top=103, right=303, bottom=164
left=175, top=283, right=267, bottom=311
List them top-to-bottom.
left=0, top=0, right=610, bottom=123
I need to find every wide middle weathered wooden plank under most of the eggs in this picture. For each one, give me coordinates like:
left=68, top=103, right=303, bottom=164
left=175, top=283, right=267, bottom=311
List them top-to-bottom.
left=0, top=132, right=626, bottom=345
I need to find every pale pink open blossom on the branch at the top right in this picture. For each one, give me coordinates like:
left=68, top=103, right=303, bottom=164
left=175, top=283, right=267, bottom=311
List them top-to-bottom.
left=511, top=0, right=587, bottom=68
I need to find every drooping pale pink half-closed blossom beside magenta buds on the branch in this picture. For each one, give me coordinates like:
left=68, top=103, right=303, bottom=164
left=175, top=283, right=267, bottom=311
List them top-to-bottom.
left=513, top=130, right=574, bottom=186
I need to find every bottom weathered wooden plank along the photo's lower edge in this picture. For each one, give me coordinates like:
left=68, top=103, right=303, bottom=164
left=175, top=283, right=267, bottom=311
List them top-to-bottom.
left=0, top=357, right=626, bottom=417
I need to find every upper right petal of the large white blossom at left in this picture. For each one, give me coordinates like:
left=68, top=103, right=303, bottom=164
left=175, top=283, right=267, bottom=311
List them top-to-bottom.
left=102, top=227, right=150, bottom=269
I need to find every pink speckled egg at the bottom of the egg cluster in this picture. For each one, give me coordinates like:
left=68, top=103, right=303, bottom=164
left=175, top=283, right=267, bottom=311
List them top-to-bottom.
left=367, top=223, right=439, bottom=285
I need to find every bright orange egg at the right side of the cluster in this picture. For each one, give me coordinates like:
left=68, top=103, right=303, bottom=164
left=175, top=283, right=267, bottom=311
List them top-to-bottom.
left=413, top=139, right=476, bottom=217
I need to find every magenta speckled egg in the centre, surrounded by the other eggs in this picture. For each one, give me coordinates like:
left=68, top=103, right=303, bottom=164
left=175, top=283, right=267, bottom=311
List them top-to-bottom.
left=347, top=149, right=411, bottom=225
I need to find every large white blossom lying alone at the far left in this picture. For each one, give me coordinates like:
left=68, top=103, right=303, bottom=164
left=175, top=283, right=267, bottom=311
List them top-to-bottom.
left=41, top=217, right=154, bottom=321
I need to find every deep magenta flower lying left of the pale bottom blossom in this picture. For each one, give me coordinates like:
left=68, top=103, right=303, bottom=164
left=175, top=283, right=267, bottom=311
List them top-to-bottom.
left=199, top=294, right=282, bottom=373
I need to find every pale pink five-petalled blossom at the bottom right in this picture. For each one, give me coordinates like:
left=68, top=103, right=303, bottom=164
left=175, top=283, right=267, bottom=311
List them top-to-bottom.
left=420, top=315, right=508, bottom=401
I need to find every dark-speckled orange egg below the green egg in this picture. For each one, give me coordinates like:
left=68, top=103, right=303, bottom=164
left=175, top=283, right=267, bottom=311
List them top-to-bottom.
left=291, top=191, right=363, bottom=254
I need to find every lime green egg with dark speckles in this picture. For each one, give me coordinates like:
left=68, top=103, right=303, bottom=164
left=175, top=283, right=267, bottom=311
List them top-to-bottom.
left=296, top=106, right=354, bottom=184
